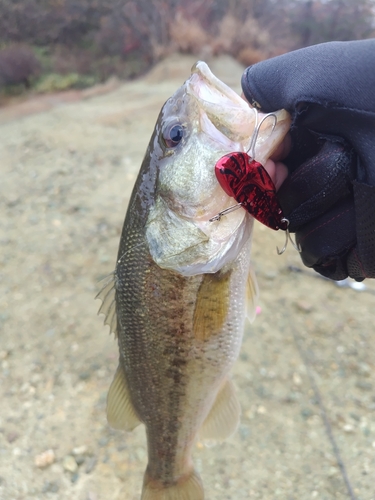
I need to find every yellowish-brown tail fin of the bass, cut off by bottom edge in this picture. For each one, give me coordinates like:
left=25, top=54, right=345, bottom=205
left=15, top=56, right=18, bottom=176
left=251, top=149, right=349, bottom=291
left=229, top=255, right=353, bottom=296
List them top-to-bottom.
left=141, top=470, right=204, bottom=500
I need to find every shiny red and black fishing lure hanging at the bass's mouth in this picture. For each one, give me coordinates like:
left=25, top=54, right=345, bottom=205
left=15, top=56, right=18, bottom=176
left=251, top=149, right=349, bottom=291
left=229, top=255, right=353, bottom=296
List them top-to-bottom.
left=215, top=152, right=288, bottom=230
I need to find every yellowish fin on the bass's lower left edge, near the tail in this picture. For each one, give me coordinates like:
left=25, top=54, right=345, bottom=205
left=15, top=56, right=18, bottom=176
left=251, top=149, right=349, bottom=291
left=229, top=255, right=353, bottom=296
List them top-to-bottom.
left=107, top=366, right=141, bottom=431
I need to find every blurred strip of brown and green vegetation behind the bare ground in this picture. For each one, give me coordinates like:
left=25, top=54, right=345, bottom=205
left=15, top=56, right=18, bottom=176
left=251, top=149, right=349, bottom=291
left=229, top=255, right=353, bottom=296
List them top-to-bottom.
left=0, top=0, right=375, bottom=93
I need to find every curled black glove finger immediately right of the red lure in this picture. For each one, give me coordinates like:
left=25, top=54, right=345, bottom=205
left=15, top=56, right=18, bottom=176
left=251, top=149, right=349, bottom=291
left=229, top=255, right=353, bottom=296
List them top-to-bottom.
left=278, top=140, right=355, bottom=232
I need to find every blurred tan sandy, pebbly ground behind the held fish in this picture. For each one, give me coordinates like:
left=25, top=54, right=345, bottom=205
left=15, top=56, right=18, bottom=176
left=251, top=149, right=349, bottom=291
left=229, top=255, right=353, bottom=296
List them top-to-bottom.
left=0, top=56, right=375, bottom=500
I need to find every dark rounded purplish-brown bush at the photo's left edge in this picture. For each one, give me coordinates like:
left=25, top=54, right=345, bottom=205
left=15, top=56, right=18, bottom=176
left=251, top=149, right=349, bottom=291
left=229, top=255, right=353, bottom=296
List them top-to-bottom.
left=0, top=45, right=40, bottom=87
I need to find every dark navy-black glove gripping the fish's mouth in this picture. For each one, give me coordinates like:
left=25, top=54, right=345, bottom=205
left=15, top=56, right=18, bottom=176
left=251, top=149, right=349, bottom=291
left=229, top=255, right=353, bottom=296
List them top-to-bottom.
left=242, top=39, right=375, bottom=281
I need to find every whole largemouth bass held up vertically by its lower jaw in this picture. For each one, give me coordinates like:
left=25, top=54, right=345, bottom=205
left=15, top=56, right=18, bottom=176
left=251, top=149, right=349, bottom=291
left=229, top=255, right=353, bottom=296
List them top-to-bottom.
left=98, top=62, right=290, bottom=500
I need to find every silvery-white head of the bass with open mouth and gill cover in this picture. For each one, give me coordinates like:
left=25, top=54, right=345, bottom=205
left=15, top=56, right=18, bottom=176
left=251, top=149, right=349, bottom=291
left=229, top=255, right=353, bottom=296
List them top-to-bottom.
left=146, top=62, right=285, bottom=276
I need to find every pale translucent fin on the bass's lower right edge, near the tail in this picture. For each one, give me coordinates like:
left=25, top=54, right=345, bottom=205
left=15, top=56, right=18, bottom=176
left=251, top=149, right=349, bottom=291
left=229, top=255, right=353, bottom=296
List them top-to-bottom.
left=199, top=379, right=241, bottom=443
